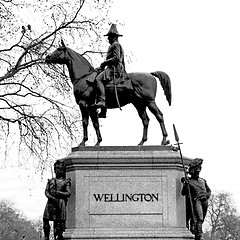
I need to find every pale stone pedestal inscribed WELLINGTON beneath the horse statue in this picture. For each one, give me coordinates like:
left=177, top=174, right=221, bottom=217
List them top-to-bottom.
left=64, top=146, right=193, bottom=240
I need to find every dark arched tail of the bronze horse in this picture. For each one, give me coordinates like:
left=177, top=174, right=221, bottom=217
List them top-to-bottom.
left=151, top=71, right=172, bottom=106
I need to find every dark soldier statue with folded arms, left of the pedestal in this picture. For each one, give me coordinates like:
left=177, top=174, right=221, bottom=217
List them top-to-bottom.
left=43, top=160, right=71, bottom=240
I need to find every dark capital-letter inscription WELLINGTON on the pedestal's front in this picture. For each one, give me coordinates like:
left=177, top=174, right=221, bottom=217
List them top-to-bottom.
left=93, top=193, right=159, bottom=202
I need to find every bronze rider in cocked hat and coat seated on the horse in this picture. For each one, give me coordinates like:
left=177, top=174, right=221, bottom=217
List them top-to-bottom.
left=95, top=24, right=127, bottom=108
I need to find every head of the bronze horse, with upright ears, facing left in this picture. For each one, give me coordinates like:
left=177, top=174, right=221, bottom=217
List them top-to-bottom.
left=45, top=41, right=67, bottom=64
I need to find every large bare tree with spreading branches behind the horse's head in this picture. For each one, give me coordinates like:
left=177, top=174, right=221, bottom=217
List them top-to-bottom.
left=0, top=0, right=109, bottom=169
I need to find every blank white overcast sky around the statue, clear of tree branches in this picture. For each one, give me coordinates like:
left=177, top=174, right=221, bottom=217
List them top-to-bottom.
left=0, top=0, right=240, bottom=218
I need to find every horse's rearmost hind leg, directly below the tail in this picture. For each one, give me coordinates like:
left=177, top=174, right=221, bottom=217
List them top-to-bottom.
left=147, top=102, right=170, bottom=145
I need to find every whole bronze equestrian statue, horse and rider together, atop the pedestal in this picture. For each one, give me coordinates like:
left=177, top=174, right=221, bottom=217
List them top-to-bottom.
left=46, top=24, right=172, bottom=146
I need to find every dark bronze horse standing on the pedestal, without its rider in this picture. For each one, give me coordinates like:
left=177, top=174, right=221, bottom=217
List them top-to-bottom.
left=46, top=42, right=171, bottom=146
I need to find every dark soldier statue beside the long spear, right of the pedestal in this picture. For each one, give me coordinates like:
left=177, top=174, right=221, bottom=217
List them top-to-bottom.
left=182, top=158, right=211, bottom=240
